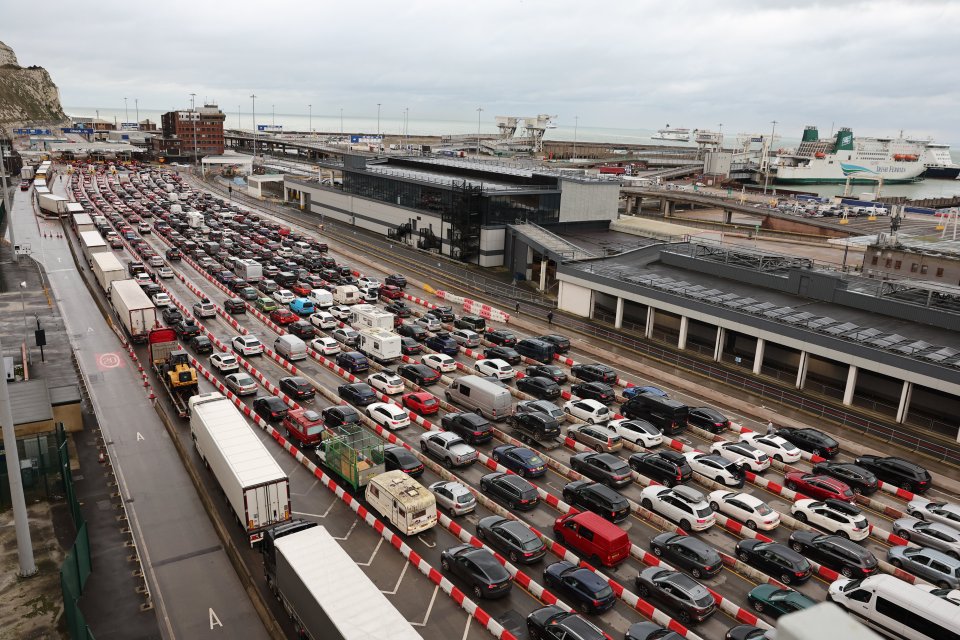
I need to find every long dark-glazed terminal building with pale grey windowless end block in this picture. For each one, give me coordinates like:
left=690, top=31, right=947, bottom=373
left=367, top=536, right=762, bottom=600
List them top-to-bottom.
left=284, top=155, right=620, bottom=266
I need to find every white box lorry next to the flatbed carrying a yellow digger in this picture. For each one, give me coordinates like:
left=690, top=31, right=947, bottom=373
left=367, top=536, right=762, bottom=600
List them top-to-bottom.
left=190, top=392, right=291, bottom=545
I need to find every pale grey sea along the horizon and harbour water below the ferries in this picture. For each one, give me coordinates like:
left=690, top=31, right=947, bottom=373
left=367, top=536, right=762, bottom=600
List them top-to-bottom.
left=64, top=106, right=960, bottom=199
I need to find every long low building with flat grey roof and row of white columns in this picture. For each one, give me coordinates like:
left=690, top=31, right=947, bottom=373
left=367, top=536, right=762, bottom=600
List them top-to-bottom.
left=557, top=242, right=960, bottom=442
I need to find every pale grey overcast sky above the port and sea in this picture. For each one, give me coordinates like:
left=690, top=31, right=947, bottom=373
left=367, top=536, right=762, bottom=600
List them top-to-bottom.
left=7, top=0, right=960, bottom=142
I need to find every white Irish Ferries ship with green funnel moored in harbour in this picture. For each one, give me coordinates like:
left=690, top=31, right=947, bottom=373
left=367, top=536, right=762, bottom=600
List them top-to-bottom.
left=771, top=127, right=927, bottom=184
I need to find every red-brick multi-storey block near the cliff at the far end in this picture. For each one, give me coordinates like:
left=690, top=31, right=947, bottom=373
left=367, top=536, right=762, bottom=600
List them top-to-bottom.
left=160, top=104, right=227, bottom=160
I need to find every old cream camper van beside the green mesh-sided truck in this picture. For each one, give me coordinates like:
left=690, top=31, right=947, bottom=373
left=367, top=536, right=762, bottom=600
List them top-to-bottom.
left=365, top=469, right=437, bottom=536
